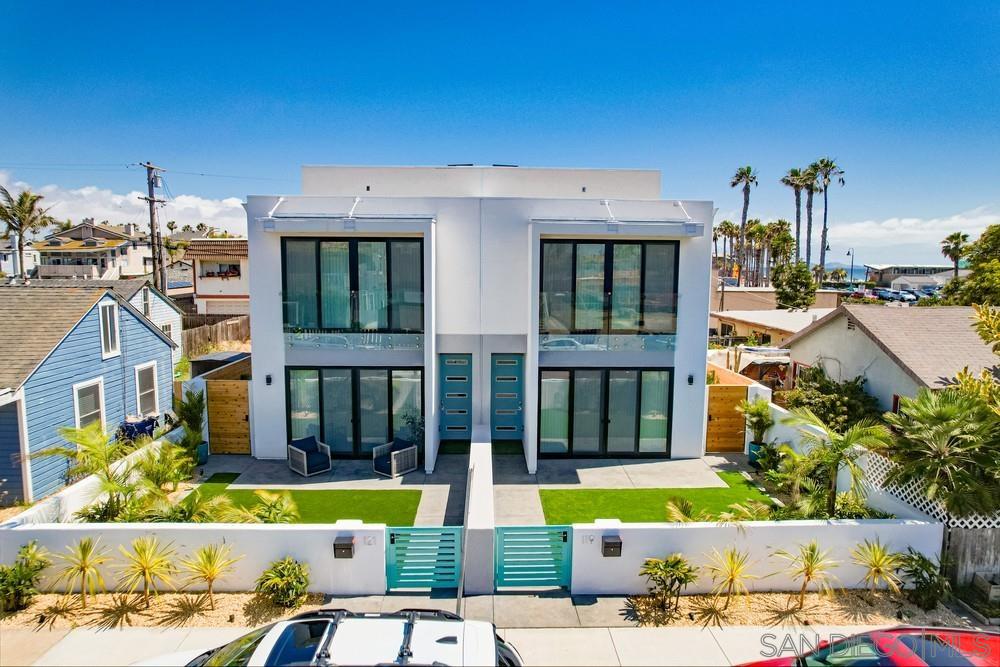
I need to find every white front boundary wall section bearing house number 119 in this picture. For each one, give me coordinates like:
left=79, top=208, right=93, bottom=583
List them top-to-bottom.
left=572, top=519, right=943, bottom=595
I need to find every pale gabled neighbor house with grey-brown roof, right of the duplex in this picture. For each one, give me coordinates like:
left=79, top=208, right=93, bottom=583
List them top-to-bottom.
left=784, top=305, right=1000, bottom=410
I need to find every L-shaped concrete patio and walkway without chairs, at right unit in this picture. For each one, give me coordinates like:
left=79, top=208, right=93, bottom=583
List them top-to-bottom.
left=493, top=456, right=734, bottom=526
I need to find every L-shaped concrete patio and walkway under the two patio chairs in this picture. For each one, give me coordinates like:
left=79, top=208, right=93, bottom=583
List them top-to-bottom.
left=199, top=455, right=469, bottom=526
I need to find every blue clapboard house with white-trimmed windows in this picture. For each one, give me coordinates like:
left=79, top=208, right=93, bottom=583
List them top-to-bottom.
left=0, top=286, right=176, bottom=505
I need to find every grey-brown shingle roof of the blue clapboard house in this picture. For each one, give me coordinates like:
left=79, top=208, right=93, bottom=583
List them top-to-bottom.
left=0, top=287, right=107, bottom=389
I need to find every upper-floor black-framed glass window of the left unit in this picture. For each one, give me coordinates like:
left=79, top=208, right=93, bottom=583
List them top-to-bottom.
left=282, top=238, right=424, bottom=333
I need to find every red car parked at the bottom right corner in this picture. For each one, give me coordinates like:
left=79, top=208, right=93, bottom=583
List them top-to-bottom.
left=744, top=627, right=1000, bottom=667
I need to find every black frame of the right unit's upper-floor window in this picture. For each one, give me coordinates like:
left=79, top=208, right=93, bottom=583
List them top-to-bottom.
left=538, top=238, right=680, bottom=336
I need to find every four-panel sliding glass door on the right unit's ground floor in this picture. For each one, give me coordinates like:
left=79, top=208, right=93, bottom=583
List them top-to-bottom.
left=538, top=368, right=673, bottom=457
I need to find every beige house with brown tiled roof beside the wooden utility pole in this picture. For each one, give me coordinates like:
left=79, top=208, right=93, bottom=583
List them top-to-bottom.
left=184, top=238, right=250, bottom=315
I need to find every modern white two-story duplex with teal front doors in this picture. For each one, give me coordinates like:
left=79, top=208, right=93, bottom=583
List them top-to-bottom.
left=246, top=166, right=713, bottom=473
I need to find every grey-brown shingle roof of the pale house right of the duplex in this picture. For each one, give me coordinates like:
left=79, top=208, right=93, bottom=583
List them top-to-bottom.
left=784, top=304, right=1000, bottom=388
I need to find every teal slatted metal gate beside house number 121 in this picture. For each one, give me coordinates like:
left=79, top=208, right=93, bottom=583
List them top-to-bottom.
left=385, top=526, right=462, bottom=589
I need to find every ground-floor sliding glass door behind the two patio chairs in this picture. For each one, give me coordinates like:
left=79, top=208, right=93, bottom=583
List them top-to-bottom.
left=287, top=368, right=423, bottom=458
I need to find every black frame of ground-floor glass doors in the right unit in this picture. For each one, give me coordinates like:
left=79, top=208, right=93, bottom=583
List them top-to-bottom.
left=535, top=366, right=676, bottom=459
